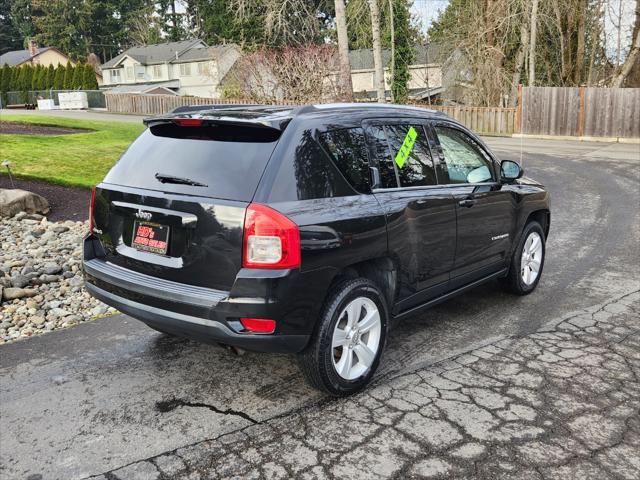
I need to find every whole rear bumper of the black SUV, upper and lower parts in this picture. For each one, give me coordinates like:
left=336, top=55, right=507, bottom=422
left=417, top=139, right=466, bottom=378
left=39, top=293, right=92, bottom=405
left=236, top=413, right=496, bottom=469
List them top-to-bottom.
left=83, top=235, right=335, bottom=353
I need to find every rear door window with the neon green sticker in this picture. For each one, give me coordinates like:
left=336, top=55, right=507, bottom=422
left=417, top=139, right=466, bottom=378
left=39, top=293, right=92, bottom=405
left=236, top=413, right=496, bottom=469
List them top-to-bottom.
left=384, top=125, right=438, bottom=187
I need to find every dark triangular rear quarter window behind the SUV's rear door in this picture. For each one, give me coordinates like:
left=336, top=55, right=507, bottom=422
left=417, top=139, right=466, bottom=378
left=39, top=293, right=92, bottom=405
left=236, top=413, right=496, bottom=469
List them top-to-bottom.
left=320, top=128, right=371, bottom=193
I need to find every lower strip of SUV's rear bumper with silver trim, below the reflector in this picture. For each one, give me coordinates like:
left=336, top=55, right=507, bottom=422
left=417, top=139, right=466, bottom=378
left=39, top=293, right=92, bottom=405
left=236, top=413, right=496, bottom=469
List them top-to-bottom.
left=85, top=282, right=309, bottom=353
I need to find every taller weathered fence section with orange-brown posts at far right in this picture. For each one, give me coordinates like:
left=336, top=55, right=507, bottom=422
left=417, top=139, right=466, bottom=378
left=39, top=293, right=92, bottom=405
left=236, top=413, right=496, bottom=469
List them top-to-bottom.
left=516, top=87, right=640, bottom=138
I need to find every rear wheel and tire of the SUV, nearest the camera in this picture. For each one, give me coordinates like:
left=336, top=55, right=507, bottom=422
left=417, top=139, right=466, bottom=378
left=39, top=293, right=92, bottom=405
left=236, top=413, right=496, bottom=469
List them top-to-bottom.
left=298, top=278, right=389, bottom=397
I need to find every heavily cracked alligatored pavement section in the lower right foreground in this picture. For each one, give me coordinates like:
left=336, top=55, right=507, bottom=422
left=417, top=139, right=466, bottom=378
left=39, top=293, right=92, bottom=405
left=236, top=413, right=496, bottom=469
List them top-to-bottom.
left=91, top=292, right=640, bottom=480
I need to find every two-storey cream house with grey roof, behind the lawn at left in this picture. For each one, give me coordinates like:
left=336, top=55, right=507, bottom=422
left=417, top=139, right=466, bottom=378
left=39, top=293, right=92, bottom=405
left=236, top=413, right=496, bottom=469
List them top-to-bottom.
left=102, top=40, right=241, bottom=98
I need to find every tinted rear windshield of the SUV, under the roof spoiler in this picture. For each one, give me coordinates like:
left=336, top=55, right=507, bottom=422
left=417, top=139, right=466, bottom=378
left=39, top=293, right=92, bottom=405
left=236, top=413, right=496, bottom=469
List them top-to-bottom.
left=104, top=124, right=279, bottom=201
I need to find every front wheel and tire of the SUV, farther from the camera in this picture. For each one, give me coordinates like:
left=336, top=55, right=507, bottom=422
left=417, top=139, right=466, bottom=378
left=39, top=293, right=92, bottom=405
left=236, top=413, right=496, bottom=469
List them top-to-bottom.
left=502, top=221, right=546, bottom=295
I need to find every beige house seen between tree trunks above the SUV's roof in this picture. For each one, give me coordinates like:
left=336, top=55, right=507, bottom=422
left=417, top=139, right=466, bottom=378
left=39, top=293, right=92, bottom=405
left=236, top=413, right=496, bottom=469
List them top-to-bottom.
left=349, top=44, right=443, bottom=101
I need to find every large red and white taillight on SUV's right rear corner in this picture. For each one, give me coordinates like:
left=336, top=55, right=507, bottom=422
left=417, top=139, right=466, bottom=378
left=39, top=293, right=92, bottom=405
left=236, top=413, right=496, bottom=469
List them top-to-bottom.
left=242, top=203, right=300, bottom=268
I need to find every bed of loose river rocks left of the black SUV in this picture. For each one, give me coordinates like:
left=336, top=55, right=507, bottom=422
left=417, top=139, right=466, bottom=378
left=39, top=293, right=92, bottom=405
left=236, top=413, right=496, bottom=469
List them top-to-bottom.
left=0, top=212, right=115, bottom=344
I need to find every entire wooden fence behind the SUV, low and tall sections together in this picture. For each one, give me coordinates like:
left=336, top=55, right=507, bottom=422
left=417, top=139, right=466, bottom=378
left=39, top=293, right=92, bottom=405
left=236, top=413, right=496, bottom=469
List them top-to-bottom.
left=105, top=87, right=640, bottom=138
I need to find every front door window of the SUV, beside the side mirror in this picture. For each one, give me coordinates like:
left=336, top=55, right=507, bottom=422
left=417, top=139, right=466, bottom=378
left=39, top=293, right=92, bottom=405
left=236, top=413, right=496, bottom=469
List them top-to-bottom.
left=435, top=126, right=493, bottom=183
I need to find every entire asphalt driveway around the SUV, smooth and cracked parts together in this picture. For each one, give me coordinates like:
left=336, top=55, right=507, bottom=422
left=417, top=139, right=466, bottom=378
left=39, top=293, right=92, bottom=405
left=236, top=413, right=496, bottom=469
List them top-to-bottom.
left=0, top=139, right=640, bottom=480
